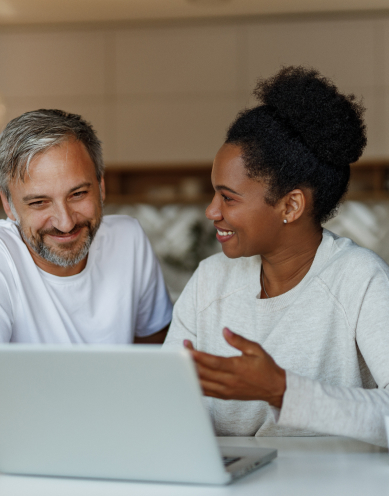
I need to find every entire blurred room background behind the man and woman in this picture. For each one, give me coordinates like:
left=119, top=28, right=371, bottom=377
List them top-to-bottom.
left=0, top=0, right=389, bottom=300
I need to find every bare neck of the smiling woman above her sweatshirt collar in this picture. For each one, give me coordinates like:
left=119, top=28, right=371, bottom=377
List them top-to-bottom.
left=261, top=227, right=323, bottom=298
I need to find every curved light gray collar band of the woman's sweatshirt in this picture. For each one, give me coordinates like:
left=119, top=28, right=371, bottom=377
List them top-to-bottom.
left=256, top=229, right=334, bottom=311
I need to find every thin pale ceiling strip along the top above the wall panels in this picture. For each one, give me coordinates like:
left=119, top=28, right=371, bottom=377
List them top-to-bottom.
left=0, top=0, right=389, bottom=25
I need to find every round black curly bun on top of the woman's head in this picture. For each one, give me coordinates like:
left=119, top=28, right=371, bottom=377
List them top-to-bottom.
left=254, top=66, right=366, bottom=166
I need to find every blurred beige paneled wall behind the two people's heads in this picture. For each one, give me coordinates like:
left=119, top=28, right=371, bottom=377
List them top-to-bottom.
left=0, top=17, right=389, bottom=162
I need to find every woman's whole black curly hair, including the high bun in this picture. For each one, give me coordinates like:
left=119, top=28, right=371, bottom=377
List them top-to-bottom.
left=226, top=66, right=366, bottom=224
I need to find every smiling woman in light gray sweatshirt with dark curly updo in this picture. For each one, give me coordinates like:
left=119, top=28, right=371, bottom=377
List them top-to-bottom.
left=162, top=67, right=389, bottom=445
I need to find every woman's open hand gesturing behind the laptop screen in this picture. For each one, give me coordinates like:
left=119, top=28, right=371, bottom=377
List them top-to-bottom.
left=184, top=327, right=286, bottom=408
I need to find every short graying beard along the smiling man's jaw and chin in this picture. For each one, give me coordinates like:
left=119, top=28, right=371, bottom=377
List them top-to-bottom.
left=16, top=215, right=102, bottom=267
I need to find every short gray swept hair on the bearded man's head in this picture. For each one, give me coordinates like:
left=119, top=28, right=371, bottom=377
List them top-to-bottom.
left=0, top=109, right=104, bottom=200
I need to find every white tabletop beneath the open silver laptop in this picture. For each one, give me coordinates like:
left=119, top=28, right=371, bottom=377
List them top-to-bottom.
left=0, top=437, right=389, bottom=496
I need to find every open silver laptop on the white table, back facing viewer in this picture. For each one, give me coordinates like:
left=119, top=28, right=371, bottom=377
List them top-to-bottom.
left=0, top=344, right=277, bottom=484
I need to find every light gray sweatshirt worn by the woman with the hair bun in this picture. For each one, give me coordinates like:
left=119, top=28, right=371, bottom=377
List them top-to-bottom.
left=164, top=230, right=389, bottom=446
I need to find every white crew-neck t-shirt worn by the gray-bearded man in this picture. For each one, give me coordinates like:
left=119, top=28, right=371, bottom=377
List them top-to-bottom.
left=0, top=215, right=172, bottom=344
